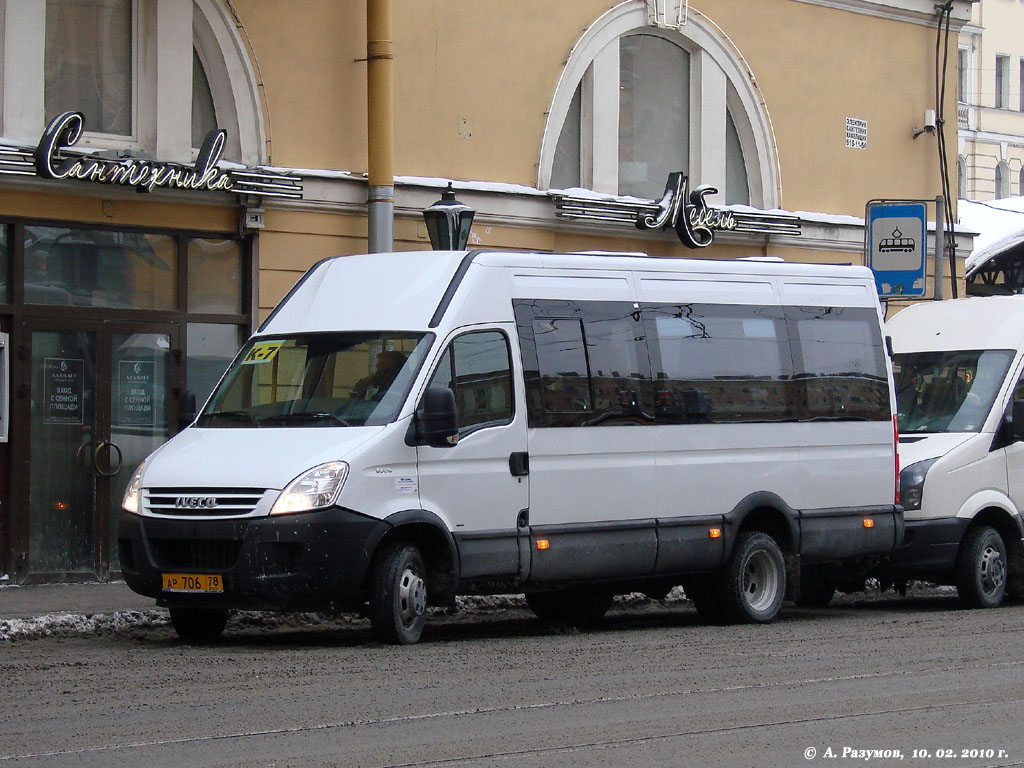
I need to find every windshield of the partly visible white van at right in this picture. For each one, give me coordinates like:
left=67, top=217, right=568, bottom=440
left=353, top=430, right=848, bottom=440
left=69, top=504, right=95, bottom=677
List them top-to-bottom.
left=893, top=349, right=1014, bottom=434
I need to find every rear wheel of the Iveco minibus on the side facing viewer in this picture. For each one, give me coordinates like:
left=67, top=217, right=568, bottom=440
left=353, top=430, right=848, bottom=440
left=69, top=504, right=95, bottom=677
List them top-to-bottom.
left=714, top=530, right=785, bottom=624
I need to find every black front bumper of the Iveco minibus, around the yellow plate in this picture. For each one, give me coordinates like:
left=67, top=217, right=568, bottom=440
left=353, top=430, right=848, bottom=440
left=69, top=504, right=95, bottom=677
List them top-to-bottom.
left=118, top=507, right=390, bottom=610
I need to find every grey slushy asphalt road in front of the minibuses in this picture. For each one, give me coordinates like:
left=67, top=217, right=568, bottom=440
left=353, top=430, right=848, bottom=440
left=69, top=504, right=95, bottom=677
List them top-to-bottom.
left=0, top=591, right=1024, bottom=768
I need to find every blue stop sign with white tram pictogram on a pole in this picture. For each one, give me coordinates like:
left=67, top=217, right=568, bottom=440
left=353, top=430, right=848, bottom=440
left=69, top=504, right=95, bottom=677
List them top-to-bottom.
left=866, top=201, right=928, bottom=297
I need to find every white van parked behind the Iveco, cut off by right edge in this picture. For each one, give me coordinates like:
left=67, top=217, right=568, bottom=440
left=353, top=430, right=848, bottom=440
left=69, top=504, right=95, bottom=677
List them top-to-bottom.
left=881, top=296, right=1024, bottom=607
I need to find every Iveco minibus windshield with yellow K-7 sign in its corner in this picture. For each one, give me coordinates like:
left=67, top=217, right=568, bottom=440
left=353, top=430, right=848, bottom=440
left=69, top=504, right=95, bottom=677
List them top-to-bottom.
left=197, top=332, right=433, bottom=428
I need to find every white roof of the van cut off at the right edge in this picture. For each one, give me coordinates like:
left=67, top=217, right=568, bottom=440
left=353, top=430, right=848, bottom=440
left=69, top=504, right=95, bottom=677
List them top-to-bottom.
left=886, top=296, right=1024, bottom=352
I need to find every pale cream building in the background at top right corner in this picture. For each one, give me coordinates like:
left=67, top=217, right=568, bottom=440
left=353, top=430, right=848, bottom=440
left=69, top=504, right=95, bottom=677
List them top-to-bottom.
left=946, top=0, right=1024, bottom=201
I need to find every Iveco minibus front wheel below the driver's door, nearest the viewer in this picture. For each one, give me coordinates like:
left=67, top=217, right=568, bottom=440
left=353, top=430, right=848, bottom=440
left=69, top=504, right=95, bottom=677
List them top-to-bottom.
left=370, top=542, right=428, bottom=645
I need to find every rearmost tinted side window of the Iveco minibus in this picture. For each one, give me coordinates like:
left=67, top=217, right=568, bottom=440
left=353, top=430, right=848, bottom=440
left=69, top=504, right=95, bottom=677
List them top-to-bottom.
left=786, top=307, right=891, bottom=421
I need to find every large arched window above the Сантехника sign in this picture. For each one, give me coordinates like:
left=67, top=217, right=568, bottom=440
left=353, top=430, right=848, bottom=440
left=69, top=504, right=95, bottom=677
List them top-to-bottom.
left=0, top=0, right=267, bottom=165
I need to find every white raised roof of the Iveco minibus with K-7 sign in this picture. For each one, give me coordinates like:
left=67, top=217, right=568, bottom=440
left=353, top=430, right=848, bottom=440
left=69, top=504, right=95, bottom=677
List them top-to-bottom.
left=259, top=251, right=870, bottom=335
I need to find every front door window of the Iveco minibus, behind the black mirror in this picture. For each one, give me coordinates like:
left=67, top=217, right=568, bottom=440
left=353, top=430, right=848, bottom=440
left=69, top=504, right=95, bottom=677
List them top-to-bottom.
left=430, top=331, right=512, bottom=434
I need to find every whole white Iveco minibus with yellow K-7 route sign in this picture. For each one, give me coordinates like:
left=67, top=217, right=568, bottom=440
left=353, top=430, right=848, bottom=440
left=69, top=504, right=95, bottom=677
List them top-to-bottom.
left=119, top=251, right=903, bottom=643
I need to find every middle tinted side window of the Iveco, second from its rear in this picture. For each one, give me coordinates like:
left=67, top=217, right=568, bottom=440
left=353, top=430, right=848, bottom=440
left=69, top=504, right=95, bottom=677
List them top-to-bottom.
left=643, top=304, right=794, bottom=424
